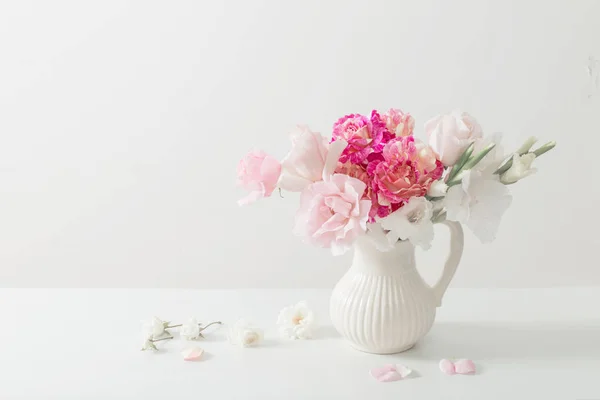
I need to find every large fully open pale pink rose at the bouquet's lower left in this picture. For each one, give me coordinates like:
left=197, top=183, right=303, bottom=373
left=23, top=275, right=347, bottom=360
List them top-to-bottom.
left=294, top=174, right=371, bottom=255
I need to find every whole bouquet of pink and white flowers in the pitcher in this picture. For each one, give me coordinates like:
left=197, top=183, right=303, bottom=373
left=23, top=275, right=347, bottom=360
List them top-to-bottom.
left=237, top=109, right=555, bottom=254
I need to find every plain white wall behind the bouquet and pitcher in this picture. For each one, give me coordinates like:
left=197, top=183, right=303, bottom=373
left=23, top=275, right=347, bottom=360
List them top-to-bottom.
left=0, top=0, right=600, bottom=288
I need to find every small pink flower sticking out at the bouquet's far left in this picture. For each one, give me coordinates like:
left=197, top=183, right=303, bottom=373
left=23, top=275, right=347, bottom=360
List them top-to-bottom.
left=237, top=150, right=281, bottom=206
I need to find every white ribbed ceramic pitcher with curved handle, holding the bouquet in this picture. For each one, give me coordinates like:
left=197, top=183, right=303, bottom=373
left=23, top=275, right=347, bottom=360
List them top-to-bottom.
left=330, top=221, right=464, bottom=354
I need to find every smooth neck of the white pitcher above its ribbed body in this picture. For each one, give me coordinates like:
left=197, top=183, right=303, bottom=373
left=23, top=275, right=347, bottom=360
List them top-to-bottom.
left=352, top=237, right=416, bottom=275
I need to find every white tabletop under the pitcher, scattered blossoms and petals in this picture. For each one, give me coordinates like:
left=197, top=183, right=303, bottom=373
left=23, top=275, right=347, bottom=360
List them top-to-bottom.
left=0, top=288, right=600, bottom=400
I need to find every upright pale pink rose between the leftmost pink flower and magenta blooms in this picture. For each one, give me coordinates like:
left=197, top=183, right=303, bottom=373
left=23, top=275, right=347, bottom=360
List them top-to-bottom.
left=279, top=125, right=347, bottom=192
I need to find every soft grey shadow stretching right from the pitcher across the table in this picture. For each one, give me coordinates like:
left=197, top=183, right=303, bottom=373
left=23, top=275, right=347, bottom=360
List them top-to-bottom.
left=402, top=321, right=600, bottom=361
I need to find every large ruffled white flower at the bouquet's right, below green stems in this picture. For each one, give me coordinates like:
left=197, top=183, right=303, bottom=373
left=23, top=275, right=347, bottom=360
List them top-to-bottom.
left=445, top=170, right=512, bottom=243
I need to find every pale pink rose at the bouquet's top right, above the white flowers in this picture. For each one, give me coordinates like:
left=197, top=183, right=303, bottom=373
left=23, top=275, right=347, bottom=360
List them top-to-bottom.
left=425, top=111, right=482, bottom=167
